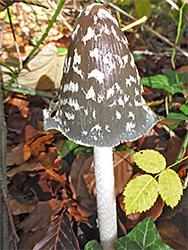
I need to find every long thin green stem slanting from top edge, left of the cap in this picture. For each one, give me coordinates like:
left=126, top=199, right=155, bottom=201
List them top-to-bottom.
left=5, top=0, right=65, bottom=95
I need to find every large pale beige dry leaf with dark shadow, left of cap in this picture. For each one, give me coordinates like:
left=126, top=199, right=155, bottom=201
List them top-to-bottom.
left=17, top=43, right=65, bottom=90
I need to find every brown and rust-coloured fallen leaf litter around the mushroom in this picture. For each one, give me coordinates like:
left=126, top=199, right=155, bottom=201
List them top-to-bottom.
left=3, top=0, right=188, bottom=250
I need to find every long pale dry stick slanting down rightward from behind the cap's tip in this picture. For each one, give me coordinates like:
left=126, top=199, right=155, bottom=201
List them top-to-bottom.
left=101, top=0, right=188, bottom=57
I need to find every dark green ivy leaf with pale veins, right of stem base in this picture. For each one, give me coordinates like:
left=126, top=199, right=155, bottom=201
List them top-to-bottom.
left=115, top=217, right=172, bottom=250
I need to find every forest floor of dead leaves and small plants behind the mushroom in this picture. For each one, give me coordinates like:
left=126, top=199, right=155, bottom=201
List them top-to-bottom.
left=0, top=1, right=188, bottom=250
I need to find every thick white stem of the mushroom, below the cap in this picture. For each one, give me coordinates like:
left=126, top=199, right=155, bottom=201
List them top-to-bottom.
left=94, top=147, right=117, bottom=250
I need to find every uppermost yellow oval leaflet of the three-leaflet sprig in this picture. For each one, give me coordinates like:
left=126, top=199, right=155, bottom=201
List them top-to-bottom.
left=133, top=149, right=166, bottom=174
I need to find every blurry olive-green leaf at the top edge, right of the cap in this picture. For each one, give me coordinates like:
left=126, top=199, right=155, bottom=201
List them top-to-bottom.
left=134, top=0, right=151, bottom=18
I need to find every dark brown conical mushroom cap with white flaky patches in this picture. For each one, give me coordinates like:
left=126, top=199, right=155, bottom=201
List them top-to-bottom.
left=44, top=4, right=159, bottom=147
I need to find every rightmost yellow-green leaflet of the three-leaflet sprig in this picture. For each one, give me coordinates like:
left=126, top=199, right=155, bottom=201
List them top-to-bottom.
left=159, top=169, right=183, bottom=208
